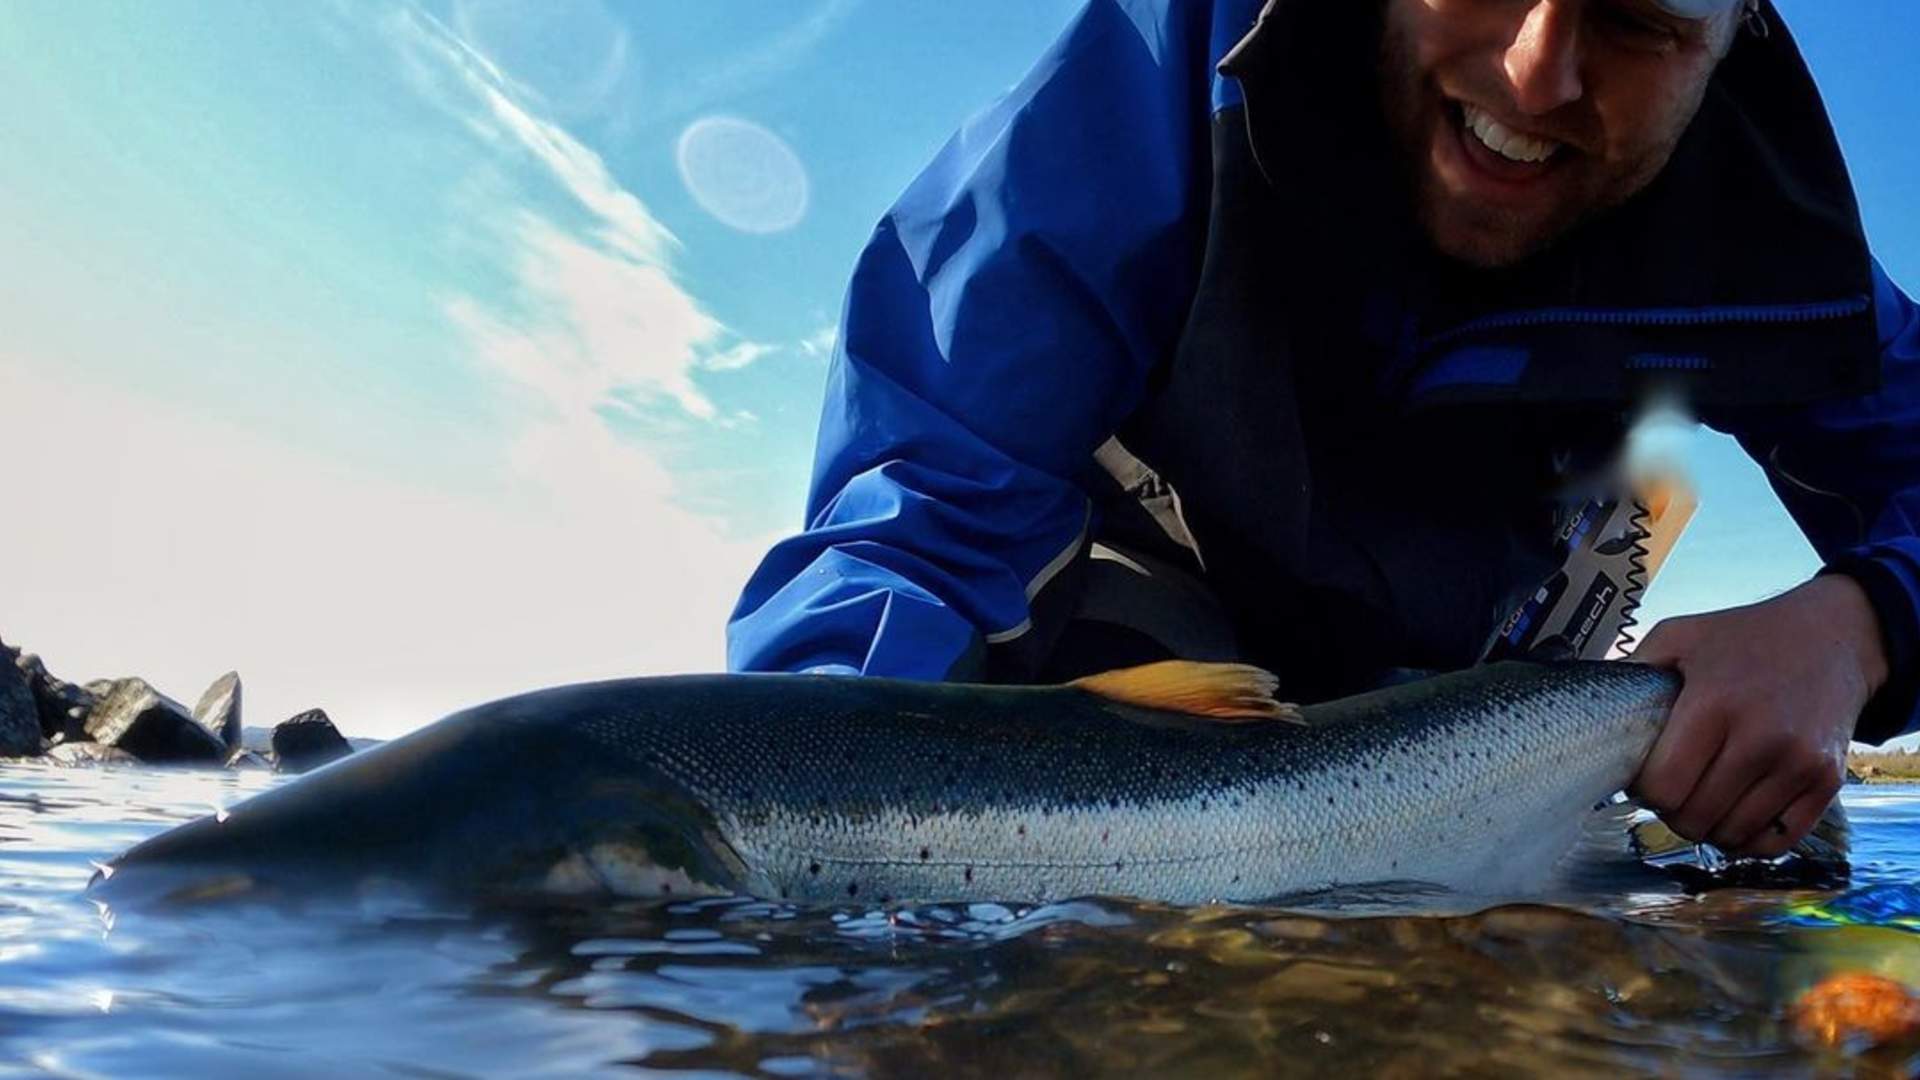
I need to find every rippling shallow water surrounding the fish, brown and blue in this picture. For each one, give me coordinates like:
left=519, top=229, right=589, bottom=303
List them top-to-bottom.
left=0, top=765, right=1920, bottom=1078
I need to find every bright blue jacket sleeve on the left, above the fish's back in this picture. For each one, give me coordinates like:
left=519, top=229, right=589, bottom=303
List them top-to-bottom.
left=728, top=0, right=1228, bottom=678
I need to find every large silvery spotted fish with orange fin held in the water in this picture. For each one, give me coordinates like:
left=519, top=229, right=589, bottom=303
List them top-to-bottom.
left=90, top=661, right=1712, bottom=903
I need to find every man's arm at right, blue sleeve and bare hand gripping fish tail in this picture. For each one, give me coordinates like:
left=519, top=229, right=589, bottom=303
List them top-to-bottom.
left=1634, top=255, right=1920, bottom=855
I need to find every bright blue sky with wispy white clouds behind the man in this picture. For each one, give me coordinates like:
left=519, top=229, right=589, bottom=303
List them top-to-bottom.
left=0, top=0, right=1920, bottom=736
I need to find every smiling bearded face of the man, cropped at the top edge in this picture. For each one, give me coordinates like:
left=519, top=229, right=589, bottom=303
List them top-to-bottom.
left=1380, top=0, right=1734, bottom=267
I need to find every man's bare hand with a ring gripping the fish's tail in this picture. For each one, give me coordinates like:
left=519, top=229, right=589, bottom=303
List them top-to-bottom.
left=1634, top=575, right=1887, bottom=857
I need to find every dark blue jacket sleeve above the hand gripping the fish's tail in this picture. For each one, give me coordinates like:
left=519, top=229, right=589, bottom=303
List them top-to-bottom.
left=1740, top=263, right=1920, bottom=744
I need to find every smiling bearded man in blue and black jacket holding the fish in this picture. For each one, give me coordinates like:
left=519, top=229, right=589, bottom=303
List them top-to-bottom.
left=730, top=0, right=1920, bottom=855
